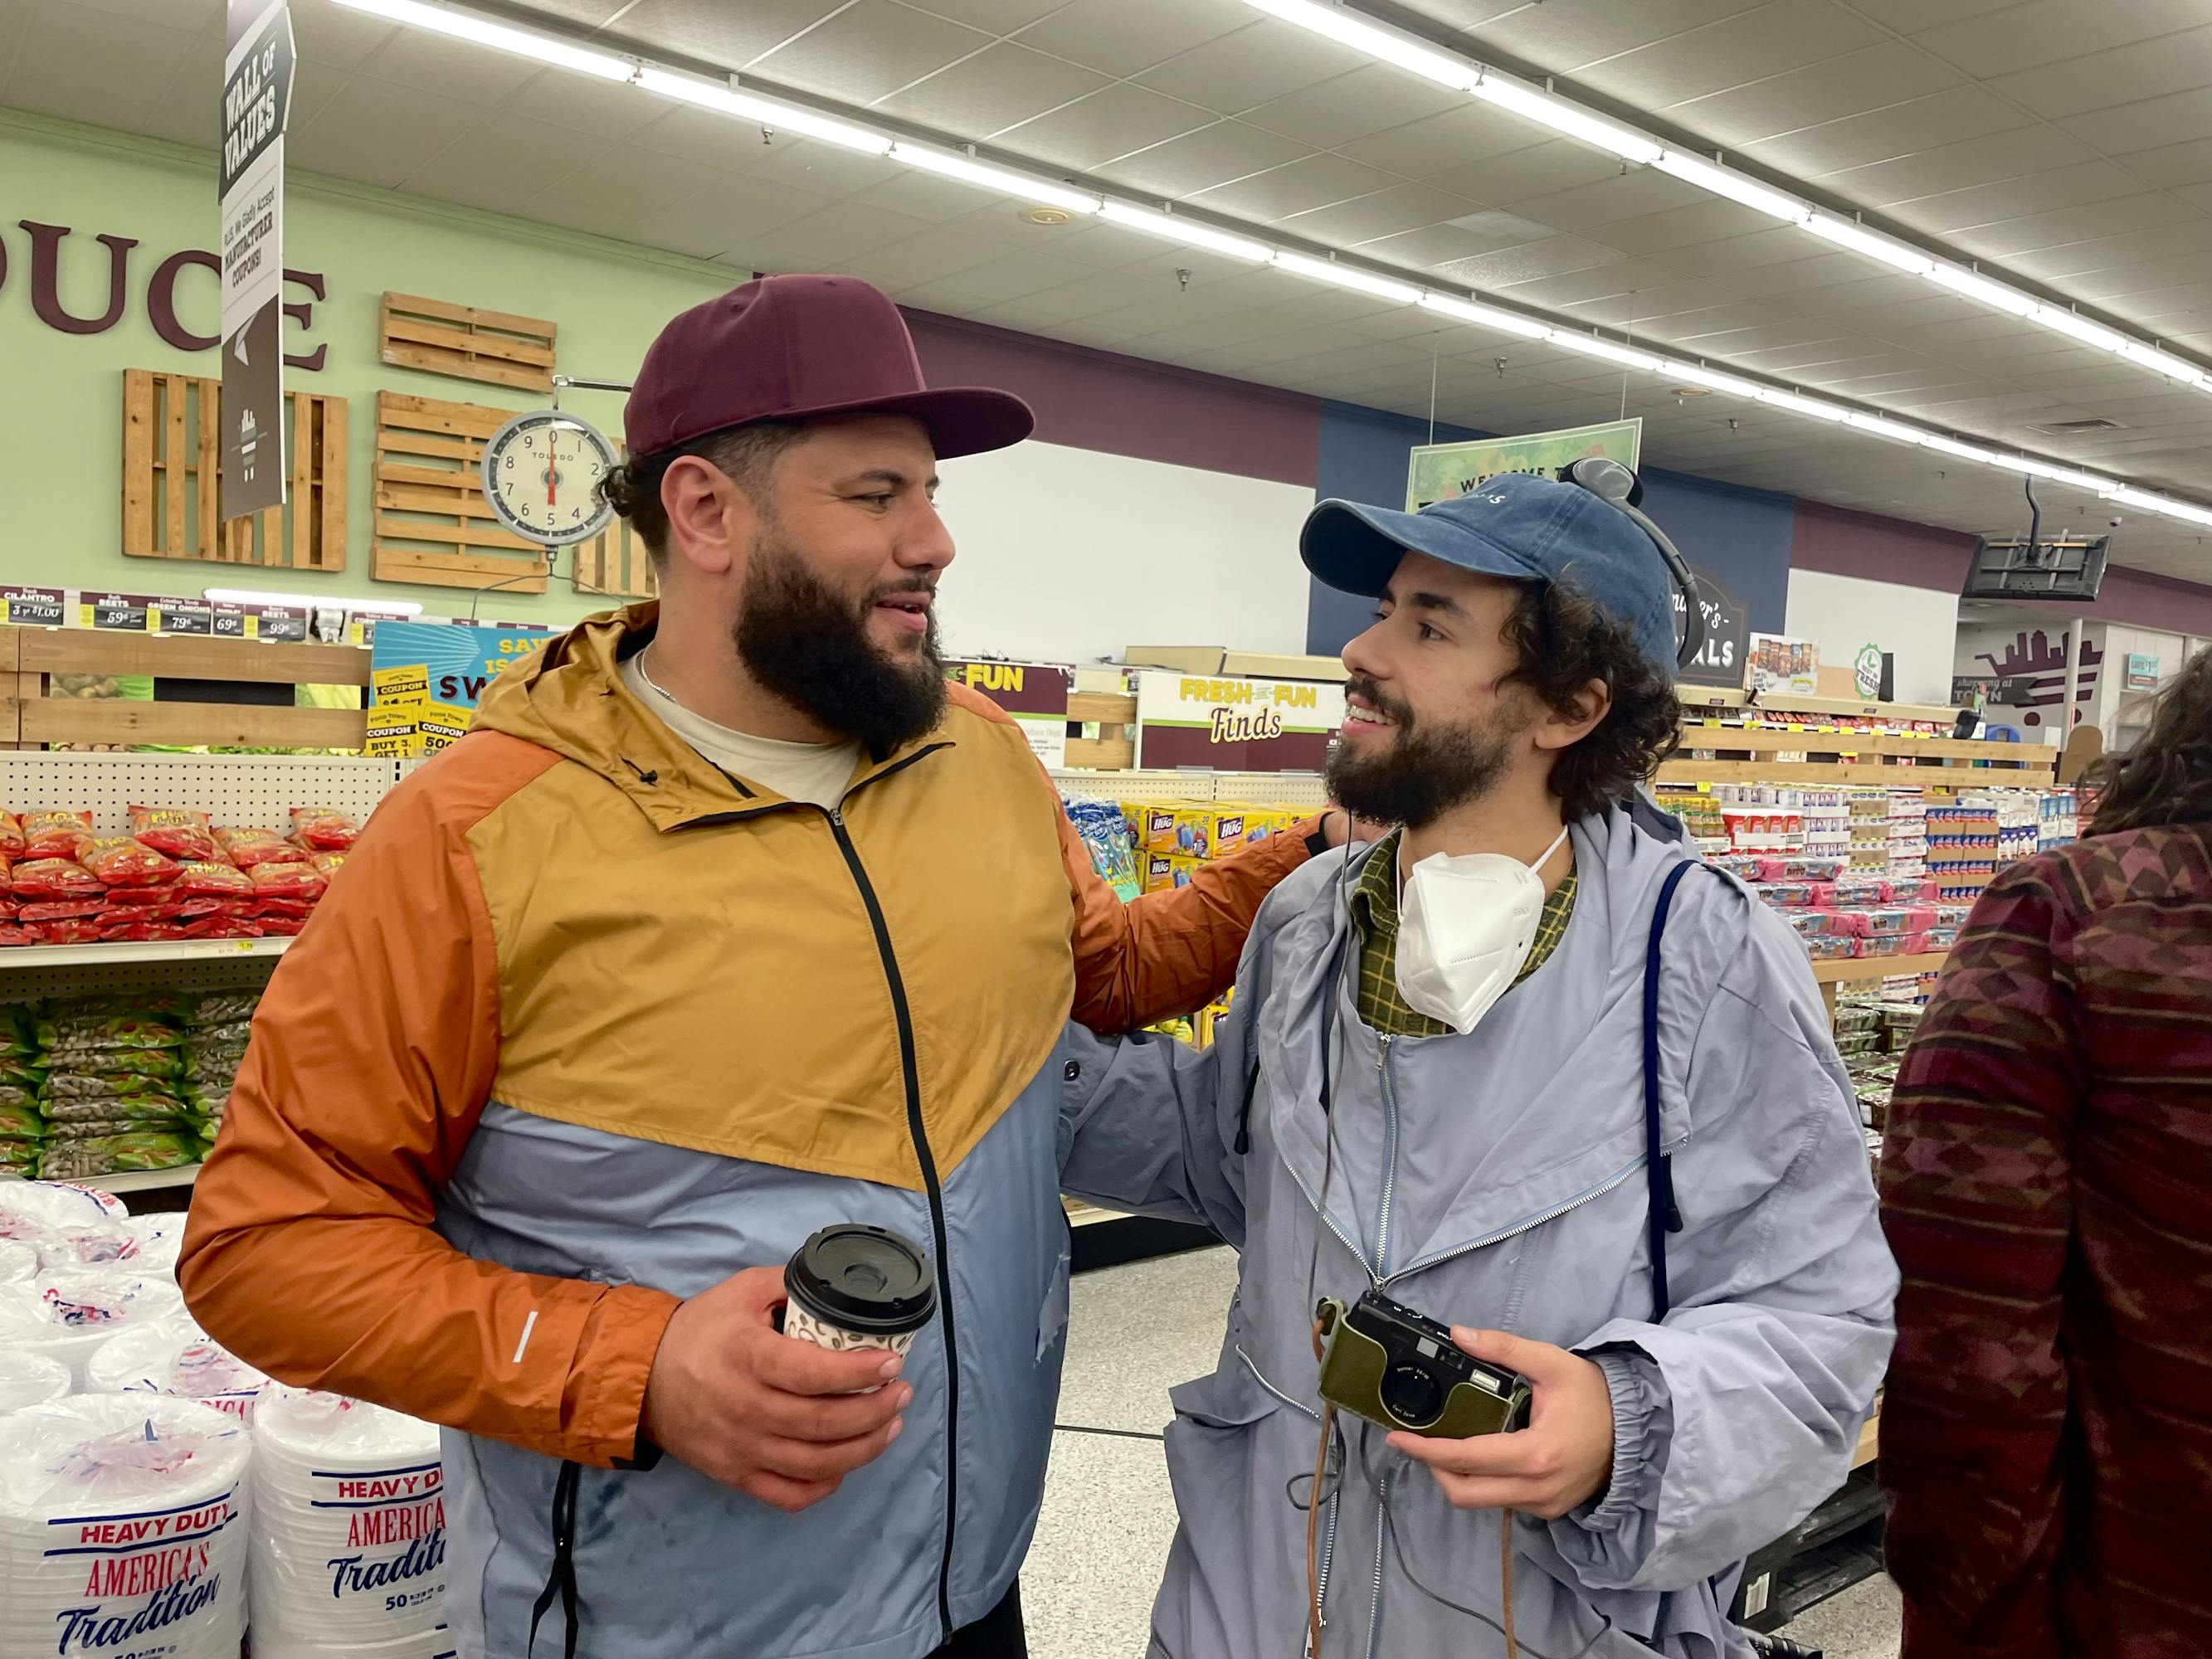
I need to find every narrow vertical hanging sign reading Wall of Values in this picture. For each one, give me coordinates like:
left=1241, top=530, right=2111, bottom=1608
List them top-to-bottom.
left=222, top=0, right=292, bottom=520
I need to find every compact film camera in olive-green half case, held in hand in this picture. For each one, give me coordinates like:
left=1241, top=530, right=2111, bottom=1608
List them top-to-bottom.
left=1314, top=1290, right=1531, bottom=1440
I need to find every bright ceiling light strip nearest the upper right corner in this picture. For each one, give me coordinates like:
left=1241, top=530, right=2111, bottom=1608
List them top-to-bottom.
left=1245, top=0, right=2212, bottom=389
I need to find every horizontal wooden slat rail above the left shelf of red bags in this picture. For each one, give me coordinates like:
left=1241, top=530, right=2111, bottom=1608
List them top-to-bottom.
left=0, top=626, right=369, bottom=750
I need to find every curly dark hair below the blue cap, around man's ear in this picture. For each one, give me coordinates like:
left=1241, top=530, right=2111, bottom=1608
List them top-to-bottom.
left=1502, top=581, right=1681, bottom=819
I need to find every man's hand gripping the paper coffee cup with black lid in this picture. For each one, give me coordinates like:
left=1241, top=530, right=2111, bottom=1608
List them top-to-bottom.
left=646, top=1267, right=914, bottom=1513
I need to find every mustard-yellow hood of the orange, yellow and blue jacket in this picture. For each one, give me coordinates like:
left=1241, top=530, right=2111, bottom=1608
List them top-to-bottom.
left=475, top=600, right=951, bottom=830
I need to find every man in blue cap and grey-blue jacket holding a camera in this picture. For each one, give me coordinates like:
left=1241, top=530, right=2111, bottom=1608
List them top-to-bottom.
left=1062, top=475, right=1896, bottom=1659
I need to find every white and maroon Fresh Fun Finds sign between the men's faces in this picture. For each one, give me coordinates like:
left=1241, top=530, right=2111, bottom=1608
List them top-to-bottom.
left=1137, top=668, right=1345, bottom=772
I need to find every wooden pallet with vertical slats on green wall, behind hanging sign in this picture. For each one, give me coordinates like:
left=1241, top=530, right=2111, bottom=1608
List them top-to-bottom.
left=122, top=369, right=348, bottom=571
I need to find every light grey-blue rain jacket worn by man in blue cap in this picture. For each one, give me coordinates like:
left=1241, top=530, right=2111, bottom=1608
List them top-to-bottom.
left=1062, top=812, right=1898, bottom=1659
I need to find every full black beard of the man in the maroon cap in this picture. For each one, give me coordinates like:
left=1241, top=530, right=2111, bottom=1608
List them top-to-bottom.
left=732, top=533, right=944, bottom=757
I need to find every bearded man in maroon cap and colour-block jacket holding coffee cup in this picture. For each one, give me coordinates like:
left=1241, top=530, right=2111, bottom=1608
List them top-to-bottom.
left=190, top=276, right=1323, bottom=1659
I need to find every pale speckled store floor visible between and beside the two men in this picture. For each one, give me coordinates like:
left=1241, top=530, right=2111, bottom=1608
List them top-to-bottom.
left=1022, top=1250, right=1898, bottom=1659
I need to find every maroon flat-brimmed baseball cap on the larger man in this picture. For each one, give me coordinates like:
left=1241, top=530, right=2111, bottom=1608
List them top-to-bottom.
left=621, top=276, right=1037, bottom=460
